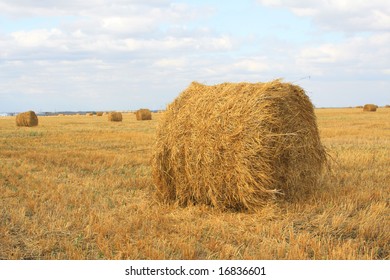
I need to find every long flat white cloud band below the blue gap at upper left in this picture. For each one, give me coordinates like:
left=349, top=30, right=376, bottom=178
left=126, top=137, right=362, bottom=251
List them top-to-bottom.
left=5, top=29, right=235, bottom=55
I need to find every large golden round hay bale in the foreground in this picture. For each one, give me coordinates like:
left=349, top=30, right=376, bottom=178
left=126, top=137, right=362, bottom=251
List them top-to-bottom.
left=152, top=80, right=326, bottom=210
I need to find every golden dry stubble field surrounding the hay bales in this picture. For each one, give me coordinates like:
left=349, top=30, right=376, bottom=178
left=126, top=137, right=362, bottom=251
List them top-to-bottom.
left=0, top=108, right=390, bottom=259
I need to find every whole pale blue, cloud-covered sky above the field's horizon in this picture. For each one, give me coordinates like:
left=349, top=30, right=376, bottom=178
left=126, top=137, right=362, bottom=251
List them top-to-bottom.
left=0, top=0, right=390, bottom=112
